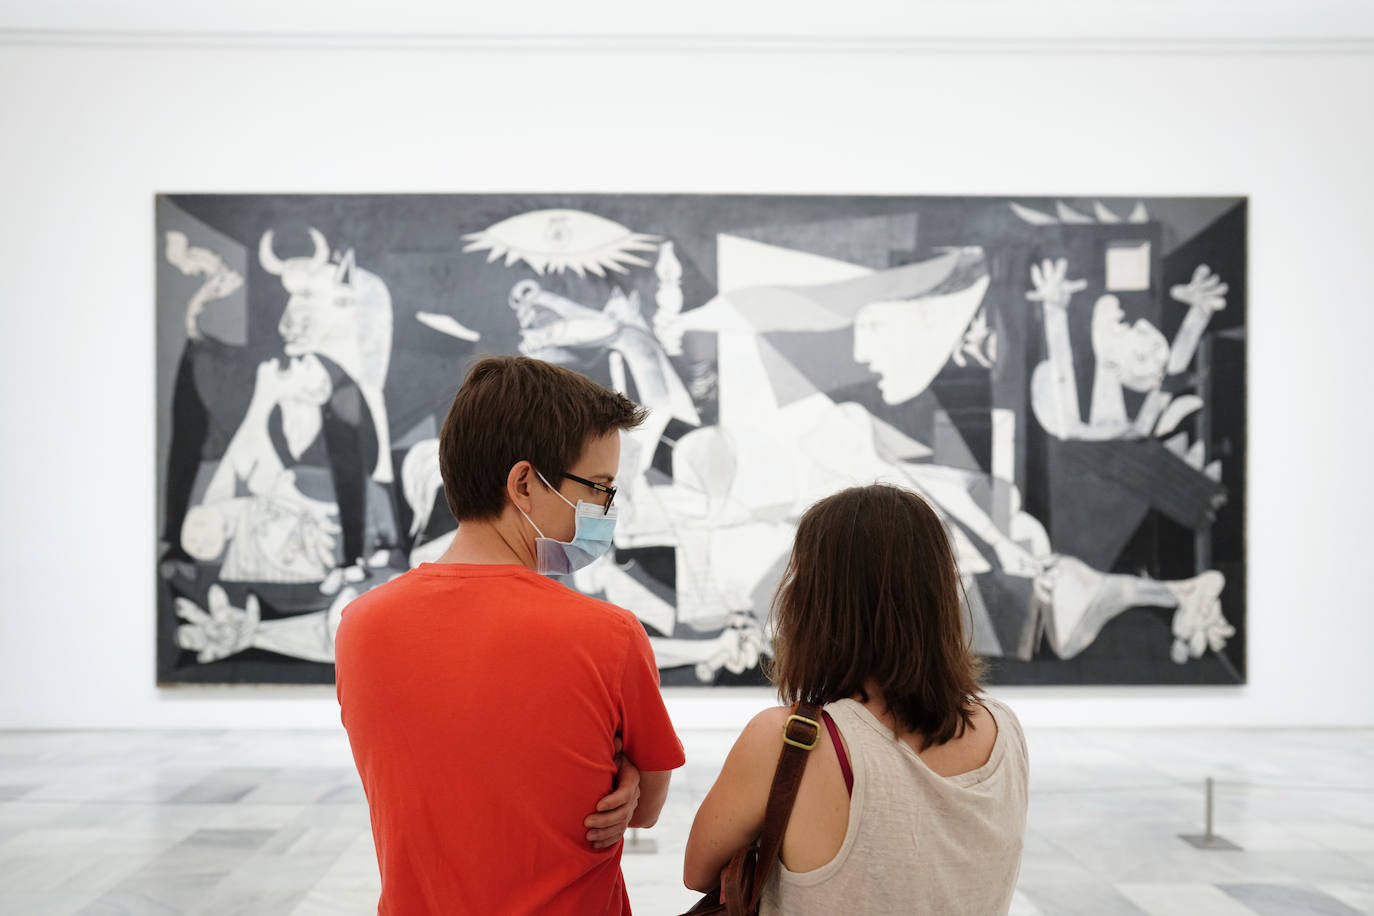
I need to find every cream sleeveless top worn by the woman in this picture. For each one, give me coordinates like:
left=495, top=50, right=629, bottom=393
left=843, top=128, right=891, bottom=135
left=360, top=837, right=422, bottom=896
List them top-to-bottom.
left=760, top=699, right=1029, bottom=916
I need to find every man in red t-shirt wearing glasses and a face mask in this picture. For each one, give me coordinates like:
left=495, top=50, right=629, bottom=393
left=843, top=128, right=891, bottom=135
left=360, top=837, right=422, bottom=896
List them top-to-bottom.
left=335, top=357, right=684, bottom=916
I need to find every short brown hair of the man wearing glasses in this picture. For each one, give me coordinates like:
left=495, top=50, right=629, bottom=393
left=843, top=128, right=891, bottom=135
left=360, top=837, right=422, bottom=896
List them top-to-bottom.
left=438, top=356, right=646, bottom=522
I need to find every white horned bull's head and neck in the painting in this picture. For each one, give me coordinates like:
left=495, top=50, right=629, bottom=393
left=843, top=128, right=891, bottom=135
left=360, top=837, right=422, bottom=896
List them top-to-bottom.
left=258, top=227, right=392, bottom=482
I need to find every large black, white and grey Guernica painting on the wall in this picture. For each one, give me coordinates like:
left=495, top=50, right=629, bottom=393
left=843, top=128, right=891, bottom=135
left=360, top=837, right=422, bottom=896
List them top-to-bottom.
left=155, top=194, right=1246, bottom=685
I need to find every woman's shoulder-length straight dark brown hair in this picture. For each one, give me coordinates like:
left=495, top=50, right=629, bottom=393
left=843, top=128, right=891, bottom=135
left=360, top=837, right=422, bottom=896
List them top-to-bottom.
left=768, top=483, right=981, bottom=748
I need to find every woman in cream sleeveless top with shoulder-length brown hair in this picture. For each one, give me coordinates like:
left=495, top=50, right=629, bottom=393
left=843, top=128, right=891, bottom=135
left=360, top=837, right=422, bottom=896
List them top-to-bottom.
left=683, top=485, right=1028, bottom=916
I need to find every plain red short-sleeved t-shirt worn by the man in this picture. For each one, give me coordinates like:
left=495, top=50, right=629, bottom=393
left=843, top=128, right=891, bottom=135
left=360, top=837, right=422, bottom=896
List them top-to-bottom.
left=335, top=563, right=684, bottom=916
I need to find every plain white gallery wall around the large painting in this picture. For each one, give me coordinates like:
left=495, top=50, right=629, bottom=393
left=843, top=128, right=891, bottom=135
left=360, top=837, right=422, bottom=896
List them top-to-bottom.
left=0, top=0, right=1374, bottom=728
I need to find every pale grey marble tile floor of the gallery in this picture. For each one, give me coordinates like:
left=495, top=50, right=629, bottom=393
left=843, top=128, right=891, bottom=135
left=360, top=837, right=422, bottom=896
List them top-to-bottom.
left=0, top=729, right=1374, bottom=916
